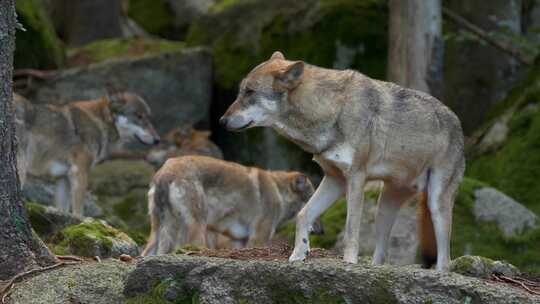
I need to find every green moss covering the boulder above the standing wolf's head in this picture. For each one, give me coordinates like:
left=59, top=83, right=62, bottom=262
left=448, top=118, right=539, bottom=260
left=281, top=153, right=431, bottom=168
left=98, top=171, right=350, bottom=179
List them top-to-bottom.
left=187, top=0, right=387, bottom=90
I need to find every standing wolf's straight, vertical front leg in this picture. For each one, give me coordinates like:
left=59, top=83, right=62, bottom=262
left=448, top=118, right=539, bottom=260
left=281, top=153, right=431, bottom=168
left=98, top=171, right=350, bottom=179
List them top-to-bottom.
left=343, top=172, right=365, bottom=263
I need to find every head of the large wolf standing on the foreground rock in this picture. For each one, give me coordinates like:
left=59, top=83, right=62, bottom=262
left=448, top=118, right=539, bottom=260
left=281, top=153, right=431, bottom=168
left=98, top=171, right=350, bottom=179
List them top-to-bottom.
left=220, top=52, right=305, bottom=131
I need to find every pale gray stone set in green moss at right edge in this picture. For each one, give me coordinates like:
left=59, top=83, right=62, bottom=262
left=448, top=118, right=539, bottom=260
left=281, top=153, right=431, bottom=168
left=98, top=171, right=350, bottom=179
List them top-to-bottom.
left=473, top=187, right=538, bottom=236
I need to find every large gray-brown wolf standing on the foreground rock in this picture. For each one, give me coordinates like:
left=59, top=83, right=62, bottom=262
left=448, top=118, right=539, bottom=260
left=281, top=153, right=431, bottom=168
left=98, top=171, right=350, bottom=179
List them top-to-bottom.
left=220, top=52, right=465, bottom=270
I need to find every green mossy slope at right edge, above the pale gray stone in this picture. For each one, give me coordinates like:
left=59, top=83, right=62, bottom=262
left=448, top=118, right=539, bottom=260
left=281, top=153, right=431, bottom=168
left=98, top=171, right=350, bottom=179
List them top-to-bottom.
left=467, top=57, right=540, bottom=215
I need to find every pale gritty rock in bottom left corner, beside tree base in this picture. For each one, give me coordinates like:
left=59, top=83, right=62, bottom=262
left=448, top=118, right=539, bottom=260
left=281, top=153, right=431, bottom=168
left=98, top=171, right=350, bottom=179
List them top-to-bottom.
left=9, top=260, right=133, bottom=304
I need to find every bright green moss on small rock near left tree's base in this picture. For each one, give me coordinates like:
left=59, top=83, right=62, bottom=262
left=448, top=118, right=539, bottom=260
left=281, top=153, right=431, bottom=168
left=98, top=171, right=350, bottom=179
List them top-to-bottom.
left=54, top=220, right=129, bottom=256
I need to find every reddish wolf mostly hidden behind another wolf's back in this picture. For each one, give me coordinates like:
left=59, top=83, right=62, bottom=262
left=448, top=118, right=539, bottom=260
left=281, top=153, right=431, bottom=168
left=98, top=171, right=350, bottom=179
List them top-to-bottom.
left=146, top=126, right=223, bottom=168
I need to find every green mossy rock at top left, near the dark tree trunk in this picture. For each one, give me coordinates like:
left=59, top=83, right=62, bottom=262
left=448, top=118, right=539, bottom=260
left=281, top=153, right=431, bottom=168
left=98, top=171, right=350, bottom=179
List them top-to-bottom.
left=14, top=0, right=65, bottom=69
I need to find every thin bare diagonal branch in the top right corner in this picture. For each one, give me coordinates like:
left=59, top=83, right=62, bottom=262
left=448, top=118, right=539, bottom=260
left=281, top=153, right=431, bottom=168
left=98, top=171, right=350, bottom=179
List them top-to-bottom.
left=442, top=7, right=534, bottom=65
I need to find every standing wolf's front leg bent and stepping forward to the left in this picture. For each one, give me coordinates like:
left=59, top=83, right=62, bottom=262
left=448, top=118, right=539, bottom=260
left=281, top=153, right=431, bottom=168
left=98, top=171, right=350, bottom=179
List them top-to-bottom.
left=289, top=175, right=344, bottom=262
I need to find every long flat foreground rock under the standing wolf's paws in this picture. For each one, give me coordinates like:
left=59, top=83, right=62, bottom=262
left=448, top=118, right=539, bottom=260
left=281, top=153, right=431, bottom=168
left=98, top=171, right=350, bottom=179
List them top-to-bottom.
left=124, top=256, right=540, bottom=304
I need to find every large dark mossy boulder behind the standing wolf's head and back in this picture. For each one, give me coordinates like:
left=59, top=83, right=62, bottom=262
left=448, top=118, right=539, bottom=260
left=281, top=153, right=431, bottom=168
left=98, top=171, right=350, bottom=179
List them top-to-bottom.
left=186, top=0, right=387, bottom=182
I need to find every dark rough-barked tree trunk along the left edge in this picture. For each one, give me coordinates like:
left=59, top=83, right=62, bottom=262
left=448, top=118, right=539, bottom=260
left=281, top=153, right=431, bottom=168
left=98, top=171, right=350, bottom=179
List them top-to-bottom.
left=0, top=0, right=55, bottom=280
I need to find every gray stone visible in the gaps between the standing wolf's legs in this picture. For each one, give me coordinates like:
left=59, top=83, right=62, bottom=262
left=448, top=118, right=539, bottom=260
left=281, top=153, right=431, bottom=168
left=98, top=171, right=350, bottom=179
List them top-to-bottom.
left=335, top=200, right=418, bottom=265
